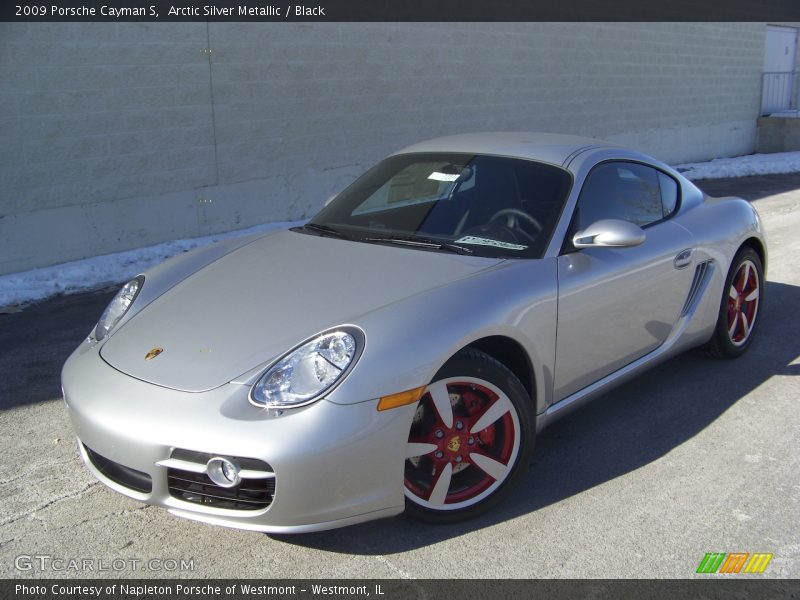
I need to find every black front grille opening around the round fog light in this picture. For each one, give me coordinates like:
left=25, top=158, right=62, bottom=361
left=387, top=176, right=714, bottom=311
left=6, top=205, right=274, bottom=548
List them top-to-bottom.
left=167, top=449, right=275, bottom=510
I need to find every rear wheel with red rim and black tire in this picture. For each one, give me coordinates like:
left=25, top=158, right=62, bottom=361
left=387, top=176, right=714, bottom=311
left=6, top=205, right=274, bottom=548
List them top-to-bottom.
left=701, top=246, right=764, bottom=358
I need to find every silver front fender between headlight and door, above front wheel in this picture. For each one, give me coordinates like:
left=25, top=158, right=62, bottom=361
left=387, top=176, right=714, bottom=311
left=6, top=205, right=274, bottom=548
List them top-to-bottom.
left=328, top=259, right=558, bottom=413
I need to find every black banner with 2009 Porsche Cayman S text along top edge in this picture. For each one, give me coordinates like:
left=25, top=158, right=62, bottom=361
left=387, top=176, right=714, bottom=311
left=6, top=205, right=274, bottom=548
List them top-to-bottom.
left=0, top=0, right=800, bottom=22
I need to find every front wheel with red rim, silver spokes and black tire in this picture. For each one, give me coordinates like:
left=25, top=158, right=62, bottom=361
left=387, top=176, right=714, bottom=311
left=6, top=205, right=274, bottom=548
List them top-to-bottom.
left=404, top=349, right=535, bottom=523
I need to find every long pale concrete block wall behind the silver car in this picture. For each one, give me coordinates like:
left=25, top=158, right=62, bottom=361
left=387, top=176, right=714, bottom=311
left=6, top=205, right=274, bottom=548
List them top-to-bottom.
left=0, top=23, right=766, bottom=274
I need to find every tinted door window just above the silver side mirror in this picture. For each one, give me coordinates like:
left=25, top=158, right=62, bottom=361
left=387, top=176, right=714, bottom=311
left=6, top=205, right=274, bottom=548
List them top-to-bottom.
left=577, top=162, right=664, bottom=229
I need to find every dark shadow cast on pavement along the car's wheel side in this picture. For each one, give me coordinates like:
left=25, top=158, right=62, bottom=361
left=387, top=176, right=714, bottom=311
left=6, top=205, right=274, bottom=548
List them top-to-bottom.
left=271, top=282, right=800, bottom=555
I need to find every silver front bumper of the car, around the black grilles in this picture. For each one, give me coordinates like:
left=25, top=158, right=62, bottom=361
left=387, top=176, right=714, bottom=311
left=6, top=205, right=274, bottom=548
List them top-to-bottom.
left=62, top=343, right=415, bottom=533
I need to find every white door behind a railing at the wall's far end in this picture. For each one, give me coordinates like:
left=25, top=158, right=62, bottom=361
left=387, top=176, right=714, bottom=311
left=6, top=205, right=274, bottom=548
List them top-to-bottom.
left=761, top=25, right=798, bottom=114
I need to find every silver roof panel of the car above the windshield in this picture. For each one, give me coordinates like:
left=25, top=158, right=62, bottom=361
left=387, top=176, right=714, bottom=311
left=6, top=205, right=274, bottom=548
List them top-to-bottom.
left=396, top=132, right=618, bottom=165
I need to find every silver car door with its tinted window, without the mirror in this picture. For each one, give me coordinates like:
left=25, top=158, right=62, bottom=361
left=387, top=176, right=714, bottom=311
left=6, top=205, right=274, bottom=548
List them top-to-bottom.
left=554, top=161, right=693, bottom=401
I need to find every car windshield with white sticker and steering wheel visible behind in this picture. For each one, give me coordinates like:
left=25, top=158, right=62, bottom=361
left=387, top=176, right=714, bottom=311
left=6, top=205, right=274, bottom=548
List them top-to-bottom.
left=302, top=153, right=572, bottom=258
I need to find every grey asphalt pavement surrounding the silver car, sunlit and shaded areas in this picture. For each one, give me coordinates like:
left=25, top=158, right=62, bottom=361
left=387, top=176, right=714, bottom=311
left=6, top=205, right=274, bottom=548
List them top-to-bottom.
left=0, top=175, right=800, bottom=578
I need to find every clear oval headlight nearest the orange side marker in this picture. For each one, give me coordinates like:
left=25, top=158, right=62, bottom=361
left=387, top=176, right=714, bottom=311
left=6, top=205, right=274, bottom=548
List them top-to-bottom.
left=250, top=327, right=364, bottom=408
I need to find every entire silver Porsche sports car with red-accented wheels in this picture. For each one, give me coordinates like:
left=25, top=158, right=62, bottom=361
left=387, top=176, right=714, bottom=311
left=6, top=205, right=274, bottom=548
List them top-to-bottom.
left=62, top=133, right=767, bottom=532
